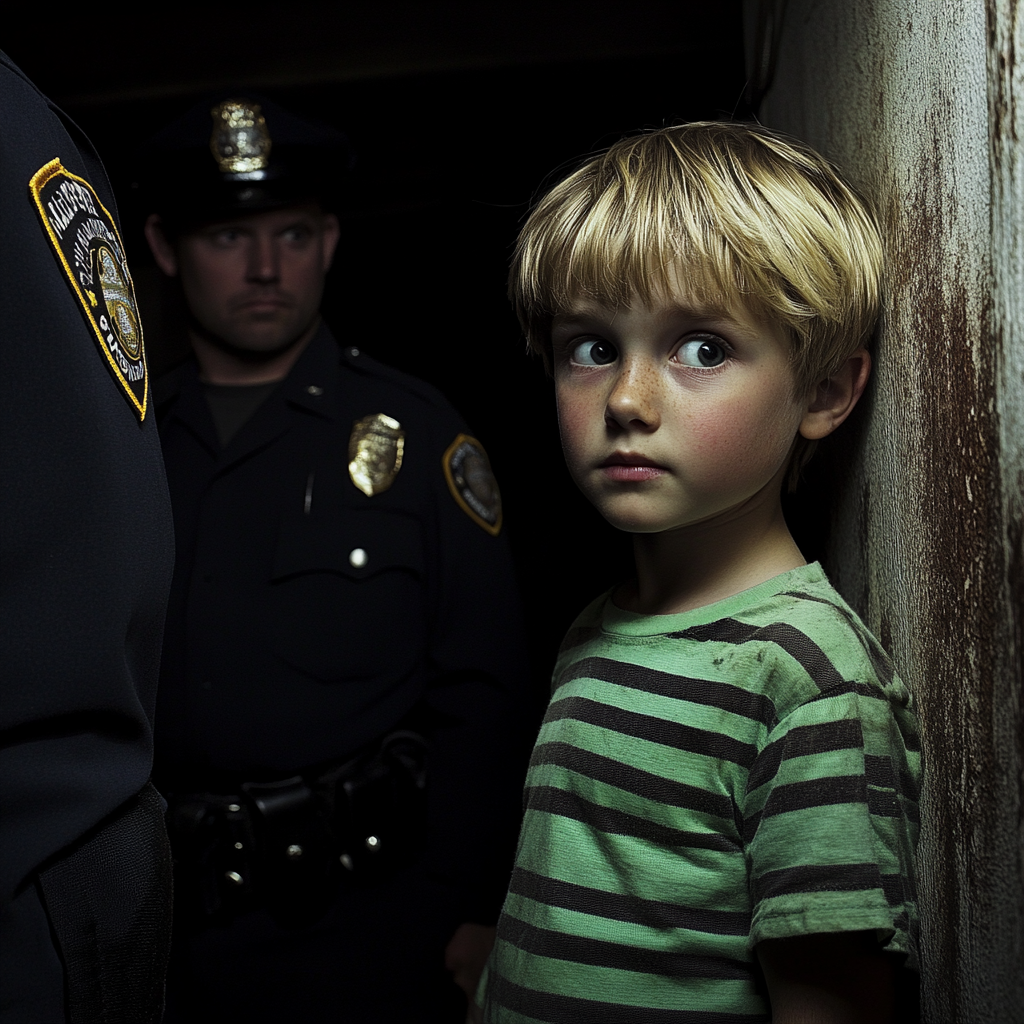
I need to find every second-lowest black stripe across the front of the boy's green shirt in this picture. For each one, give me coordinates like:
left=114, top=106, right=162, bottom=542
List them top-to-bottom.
left=498, top=912, right=752, bottom=981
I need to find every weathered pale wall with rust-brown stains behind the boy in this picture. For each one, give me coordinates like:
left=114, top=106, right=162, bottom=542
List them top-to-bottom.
left=748, top=0, right=1024, bottom=1024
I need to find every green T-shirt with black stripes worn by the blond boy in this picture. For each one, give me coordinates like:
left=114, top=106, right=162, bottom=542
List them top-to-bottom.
left=482, top=564, right=921, bottom=1024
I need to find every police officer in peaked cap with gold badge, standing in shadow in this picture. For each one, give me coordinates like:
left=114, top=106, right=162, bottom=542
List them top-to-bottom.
left=146, top=97, right=525, bottom=1022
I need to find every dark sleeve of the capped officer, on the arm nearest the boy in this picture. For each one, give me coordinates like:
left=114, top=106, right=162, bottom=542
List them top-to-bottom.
left=415, top=421, right=536, bottom=924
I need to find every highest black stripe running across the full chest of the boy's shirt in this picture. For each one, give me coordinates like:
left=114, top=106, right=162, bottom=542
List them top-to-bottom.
left=555, top=657, right=778, bottom=729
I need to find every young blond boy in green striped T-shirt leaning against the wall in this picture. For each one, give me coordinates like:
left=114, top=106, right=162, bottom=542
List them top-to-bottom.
left=480, top=123, right=920, bottom=1024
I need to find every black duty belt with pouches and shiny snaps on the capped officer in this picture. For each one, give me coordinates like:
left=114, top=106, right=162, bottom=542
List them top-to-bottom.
left=167, top=730, right=427, bottom=924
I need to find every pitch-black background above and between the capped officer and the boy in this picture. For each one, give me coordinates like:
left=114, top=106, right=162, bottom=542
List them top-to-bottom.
left=3, top=0, right=790, bottom=700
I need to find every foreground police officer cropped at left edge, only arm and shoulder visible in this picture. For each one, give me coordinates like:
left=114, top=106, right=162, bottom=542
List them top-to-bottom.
left=0, top=54, right=173, bottom=1024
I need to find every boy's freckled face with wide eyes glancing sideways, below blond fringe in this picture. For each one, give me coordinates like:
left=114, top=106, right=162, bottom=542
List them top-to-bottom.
left=552, top=289, right=808, bottom=534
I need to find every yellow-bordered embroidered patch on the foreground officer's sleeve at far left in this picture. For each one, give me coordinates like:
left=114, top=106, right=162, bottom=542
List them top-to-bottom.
left=29, top=159, right=150, bottom=421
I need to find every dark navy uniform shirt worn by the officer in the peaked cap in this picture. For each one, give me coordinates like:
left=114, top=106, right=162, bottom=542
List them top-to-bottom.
left=157, top=328, right=526, bottom=919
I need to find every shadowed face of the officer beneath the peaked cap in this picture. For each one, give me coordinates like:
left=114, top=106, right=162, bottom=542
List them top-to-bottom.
left=157, top=204, right=339, bottom=353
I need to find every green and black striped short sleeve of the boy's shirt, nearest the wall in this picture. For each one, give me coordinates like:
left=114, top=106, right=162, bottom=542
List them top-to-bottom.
left=742, top=680, right=920, bottom=968
